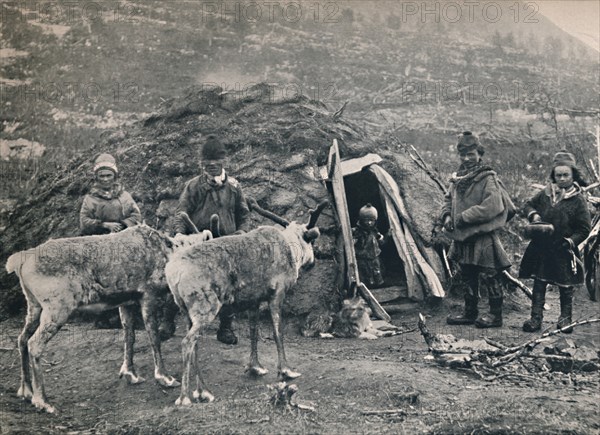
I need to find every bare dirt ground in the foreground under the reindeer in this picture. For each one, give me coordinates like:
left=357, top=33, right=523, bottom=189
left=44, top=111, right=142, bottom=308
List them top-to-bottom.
left=0, top=289, right=600, bottom=434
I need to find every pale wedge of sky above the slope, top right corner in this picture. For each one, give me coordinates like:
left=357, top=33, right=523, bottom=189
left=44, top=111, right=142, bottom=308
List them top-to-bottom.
left=531, top=0, right=600, bottom=52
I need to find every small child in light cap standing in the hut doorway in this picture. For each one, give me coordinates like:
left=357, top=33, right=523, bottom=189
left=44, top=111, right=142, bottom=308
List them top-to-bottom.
left=352, top=203, right=384, bottom=287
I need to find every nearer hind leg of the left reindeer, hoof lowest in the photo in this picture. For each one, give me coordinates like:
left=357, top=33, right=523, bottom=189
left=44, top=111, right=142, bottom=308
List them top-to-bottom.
left=28, top=300, right=73, bottom=413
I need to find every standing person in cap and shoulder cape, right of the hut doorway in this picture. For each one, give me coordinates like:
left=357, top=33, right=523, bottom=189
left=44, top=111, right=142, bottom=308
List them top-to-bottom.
left=441, top=131, right=510, bottom=328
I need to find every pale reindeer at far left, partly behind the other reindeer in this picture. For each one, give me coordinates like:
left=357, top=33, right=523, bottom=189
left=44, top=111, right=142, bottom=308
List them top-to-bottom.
left=6, top=225, right=212, bottom=413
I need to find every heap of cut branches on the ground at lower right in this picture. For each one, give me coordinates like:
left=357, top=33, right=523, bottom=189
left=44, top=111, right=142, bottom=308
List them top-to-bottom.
left=419, top=314, right=600, bottom=381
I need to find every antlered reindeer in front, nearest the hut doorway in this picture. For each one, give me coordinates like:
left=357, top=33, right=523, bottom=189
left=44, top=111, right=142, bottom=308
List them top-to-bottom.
left=165, top=202, right=327, bottom=405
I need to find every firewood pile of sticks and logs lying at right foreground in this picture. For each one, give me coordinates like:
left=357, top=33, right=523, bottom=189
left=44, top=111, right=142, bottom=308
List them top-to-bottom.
left=418, top=314, right=600, bottom=390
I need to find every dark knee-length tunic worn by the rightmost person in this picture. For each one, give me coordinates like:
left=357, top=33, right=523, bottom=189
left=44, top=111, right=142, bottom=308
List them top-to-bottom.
left=519, top=184, right=591, bottom=286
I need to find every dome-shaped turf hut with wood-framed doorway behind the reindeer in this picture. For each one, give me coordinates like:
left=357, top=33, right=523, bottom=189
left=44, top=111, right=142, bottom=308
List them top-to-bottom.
left=0, top=84, right=443, bottom=315
